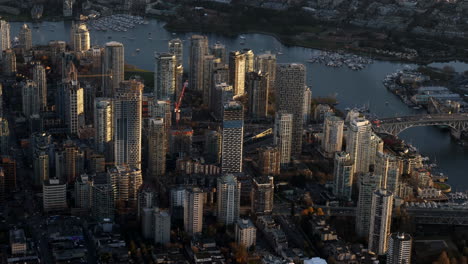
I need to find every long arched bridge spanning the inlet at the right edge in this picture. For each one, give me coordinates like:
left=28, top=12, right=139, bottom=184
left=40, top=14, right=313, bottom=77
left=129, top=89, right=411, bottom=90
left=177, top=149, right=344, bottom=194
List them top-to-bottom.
left=372, top=113, right=468, bottom=138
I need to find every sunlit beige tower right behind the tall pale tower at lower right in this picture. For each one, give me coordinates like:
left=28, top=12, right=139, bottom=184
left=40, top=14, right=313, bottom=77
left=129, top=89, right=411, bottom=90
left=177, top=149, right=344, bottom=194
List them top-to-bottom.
left=374, top=151, right=402, bottom=194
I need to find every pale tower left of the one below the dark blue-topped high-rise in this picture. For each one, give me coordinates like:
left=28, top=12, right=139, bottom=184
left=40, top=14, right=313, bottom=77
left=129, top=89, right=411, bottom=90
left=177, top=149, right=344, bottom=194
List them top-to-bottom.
left=184, top=187, right=205, bottom=236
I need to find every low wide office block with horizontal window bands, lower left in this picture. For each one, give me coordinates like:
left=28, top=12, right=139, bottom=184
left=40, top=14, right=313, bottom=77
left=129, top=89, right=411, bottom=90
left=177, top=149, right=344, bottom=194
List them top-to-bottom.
left=42, top=179, right=67, bottom=212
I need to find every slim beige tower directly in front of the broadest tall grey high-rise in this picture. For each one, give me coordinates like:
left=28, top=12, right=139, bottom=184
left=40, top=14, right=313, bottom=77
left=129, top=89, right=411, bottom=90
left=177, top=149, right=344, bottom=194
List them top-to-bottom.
left=273, top=111, right=294, bottom=168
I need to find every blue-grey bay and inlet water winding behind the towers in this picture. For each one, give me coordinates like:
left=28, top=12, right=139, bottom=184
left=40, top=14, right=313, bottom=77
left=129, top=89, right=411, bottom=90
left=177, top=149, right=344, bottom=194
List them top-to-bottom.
left=11, top=20, right=468, bottom=191
